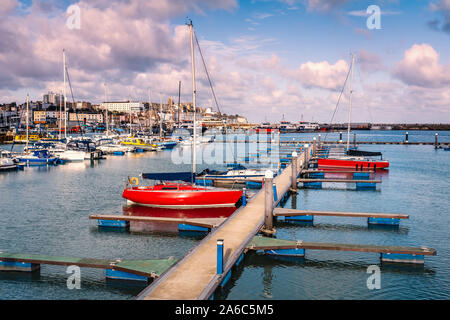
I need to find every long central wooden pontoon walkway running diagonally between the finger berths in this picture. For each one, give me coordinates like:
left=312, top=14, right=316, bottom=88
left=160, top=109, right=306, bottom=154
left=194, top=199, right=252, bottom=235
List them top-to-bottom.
left=137, top=148, right=302, bottom=300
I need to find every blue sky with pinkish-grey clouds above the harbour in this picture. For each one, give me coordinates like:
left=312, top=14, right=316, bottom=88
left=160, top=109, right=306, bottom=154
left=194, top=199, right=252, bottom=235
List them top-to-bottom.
left=0, top=0, right=450, bottom=123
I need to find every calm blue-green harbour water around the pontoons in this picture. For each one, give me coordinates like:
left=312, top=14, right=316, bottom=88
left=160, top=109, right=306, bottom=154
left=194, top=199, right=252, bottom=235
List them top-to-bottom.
left=0, top=131, right=450, bottom=299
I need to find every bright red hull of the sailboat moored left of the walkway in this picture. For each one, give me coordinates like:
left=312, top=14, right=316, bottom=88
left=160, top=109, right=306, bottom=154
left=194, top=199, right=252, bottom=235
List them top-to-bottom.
left=122, top=184, right=242, bottom=208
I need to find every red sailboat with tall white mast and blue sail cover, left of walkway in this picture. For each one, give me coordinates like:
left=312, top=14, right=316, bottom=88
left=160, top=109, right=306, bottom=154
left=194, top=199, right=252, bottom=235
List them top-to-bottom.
left=122, top=22, right=243, bottom=208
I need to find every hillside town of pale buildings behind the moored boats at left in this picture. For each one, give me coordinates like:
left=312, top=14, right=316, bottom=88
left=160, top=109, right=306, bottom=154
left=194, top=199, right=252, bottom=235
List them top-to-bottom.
left=0, top=92, right=248, bottom=136
